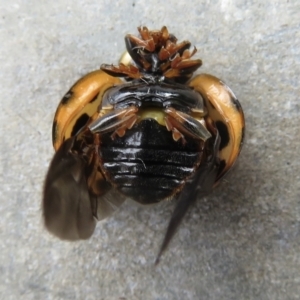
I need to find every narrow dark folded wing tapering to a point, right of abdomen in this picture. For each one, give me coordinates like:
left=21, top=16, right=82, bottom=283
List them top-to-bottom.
left=155, top=132, right=221, bottom=265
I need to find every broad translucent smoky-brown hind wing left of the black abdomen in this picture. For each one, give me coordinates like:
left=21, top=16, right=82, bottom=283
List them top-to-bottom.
left=43, top=137, right=124, bottom=240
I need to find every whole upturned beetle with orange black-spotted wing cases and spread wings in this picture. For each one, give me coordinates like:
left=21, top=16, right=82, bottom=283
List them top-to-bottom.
left=43, top=26, right=245, bottom=263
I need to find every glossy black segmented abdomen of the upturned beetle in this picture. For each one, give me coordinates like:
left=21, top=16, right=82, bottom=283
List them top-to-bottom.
left=100, top=119, right=202, bottom=204
